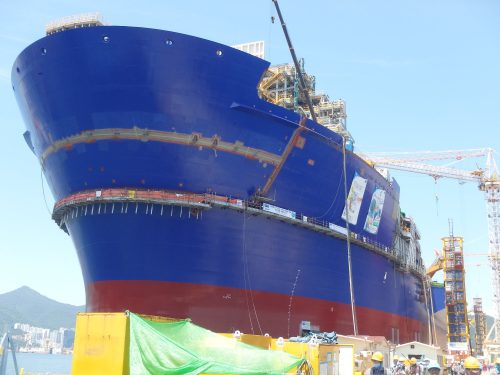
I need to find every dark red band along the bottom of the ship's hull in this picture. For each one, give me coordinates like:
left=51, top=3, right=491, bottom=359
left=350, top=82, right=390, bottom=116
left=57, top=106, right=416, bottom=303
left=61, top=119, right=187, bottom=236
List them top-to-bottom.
left=86, top=280, right=428, bottom=342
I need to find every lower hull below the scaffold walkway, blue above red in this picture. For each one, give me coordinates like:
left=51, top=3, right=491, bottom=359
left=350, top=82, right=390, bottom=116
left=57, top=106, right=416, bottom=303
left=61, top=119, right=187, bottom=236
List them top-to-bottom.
left=65, top=203, right=428, bottom=341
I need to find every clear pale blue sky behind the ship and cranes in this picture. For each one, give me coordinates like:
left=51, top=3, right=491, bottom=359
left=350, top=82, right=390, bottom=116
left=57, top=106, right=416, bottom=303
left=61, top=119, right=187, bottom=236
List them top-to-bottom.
left=0, top=0, right=500, bottom=320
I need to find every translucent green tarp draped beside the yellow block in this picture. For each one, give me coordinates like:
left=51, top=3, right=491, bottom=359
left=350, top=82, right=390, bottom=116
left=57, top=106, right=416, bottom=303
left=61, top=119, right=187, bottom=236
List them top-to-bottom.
left=129, top=313, right=304, bottom=375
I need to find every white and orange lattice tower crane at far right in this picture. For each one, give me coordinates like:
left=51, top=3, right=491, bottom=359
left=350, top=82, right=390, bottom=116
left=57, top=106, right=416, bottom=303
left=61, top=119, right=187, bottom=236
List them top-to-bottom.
left=357, top=148, right=500, bottom=346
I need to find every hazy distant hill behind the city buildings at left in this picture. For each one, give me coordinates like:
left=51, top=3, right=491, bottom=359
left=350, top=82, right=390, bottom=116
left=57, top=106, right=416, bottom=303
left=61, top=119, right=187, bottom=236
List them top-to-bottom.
left=0, top=286, right=85, bottom=332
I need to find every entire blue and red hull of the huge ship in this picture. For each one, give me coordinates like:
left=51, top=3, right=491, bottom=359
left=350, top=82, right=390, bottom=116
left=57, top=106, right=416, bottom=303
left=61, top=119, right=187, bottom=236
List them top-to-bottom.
left=12, top=27, right=429, bottom=341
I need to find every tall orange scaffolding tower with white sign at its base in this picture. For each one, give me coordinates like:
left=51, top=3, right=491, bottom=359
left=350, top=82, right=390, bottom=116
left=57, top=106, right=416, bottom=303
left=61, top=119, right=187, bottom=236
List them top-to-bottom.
left=442, top=234, right=470, bottom=356
